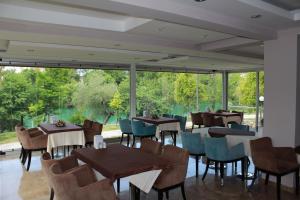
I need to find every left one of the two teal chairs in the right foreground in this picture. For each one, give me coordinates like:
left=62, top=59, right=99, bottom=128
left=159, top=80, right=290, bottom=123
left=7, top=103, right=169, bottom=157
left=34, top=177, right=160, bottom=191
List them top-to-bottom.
left=181, top=132, right=205, bottom=178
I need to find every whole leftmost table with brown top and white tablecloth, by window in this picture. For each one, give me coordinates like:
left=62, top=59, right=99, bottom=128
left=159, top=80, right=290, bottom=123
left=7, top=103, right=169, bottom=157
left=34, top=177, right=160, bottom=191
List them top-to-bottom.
left=39, top=123, right=85, bottom=153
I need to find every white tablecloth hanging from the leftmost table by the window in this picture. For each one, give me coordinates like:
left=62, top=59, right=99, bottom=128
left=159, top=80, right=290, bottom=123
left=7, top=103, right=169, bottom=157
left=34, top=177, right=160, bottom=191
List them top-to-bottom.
left=40, top=129, right=85, bottom=153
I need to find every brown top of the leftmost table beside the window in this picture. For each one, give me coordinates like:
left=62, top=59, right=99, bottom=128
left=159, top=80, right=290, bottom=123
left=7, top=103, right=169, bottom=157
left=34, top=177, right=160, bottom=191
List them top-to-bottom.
left=39, top=123, right=82, bottom=134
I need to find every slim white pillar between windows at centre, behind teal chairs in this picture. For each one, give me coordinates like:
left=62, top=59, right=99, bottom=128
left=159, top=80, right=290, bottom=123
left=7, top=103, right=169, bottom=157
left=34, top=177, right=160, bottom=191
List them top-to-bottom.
left=130, top=64, right=136, bottom=118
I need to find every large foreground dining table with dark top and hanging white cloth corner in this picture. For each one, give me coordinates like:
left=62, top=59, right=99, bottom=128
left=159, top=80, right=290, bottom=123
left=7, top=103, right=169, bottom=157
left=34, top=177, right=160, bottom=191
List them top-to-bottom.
left=72, top=144, right=172, bottom=199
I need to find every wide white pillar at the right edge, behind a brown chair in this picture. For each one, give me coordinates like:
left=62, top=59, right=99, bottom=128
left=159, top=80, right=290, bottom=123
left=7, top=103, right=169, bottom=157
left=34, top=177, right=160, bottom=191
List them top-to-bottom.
left=263, top=28, right=300, bottom=186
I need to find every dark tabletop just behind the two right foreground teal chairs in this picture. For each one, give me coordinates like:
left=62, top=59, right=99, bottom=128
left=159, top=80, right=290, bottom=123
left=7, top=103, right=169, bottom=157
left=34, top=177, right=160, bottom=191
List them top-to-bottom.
left=208, top=128, right=255, bottom=137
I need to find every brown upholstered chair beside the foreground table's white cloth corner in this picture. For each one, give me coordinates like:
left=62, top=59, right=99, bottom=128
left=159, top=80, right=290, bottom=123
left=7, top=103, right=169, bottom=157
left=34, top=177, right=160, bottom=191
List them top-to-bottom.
left=153, top=145, right=189, bottom=200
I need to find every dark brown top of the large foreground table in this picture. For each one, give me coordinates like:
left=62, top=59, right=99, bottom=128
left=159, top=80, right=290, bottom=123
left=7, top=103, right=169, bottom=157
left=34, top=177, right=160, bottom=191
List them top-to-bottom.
left=72, top=144, right=171, bottom=181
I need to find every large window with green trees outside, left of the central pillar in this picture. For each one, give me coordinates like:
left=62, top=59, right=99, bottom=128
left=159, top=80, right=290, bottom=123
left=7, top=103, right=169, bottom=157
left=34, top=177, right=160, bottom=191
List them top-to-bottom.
left=0, top=67, right=129, bottom=132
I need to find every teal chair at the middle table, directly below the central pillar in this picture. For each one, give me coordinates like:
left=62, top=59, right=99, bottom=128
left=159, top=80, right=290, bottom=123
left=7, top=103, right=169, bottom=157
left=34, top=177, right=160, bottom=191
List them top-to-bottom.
left=131, top=120, right=156, bottom=146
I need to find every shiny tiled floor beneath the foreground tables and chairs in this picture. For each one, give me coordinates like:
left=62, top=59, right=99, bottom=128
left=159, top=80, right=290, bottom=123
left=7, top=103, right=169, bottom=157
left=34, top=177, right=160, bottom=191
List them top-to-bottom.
left=0, top=138, right=300, bottom=200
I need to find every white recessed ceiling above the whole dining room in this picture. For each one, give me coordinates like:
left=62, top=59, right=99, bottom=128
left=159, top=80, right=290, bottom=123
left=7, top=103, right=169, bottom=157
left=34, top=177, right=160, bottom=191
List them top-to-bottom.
left=0, top=0, right=300, bottom=70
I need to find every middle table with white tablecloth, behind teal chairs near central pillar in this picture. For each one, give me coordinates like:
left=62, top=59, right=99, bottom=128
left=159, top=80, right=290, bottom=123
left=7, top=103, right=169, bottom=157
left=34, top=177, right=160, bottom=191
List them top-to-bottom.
left=132, top=117, right=181, bottom=146
